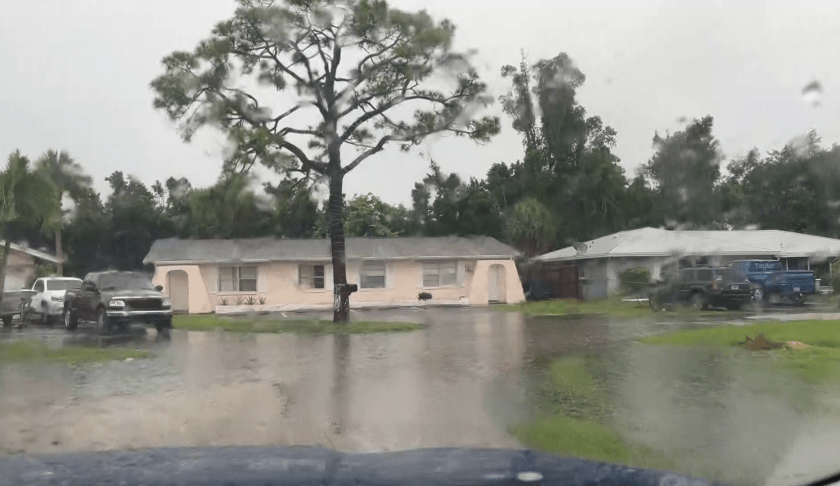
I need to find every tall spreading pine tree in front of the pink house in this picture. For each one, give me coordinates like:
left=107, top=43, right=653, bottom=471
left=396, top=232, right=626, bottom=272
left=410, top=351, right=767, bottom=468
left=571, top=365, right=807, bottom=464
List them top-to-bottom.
left=151, top=0, right=499, bottom=322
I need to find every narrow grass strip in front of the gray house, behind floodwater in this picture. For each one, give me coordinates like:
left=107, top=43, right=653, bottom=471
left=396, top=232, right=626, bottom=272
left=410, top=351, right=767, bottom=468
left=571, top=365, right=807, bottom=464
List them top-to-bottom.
left=498, top=298, right=656, bottom=317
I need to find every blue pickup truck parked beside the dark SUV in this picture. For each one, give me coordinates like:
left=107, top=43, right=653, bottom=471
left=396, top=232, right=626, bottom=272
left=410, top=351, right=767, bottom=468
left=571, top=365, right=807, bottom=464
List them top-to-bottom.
left=726, top=260, right=817, bottom=304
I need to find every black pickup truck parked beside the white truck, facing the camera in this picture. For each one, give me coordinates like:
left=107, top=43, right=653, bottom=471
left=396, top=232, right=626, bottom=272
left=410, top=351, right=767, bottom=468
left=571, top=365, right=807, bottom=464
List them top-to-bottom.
left=62, top=271, right=172, bottom=336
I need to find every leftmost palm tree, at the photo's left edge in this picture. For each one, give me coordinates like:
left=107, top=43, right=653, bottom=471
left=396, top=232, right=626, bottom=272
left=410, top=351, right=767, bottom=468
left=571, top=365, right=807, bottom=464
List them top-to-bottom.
left=0, top=150, right=61, bottom=295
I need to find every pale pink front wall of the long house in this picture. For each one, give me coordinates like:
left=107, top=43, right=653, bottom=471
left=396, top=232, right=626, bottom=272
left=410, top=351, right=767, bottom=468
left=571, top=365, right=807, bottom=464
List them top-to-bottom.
left=152, top=260, right=525, bottom=314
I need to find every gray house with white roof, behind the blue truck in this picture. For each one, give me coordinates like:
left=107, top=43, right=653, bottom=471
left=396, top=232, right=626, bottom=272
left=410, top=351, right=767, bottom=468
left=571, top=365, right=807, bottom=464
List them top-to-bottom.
left=534, top=228, right=840, bottom=299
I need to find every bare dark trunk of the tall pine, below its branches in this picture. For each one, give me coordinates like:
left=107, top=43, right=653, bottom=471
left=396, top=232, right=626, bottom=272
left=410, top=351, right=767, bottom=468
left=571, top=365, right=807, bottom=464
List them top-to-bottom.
left=329, top=171, right=353, bottom=322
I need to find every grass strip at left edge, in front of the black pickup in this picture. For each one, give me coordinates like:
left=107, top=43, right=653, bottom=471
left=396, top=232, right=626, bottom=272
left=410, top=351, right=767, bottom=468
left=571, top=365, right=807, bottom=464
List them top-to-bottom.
left=0, top=341, right=153, bottom=364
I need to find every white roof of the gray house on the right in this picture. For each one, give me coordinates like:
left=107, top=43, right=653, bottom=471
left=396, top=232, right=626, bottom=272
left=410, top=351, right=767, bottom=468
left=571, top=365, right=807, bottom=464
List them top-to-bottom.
left=535, top=228, right=840, bottom=262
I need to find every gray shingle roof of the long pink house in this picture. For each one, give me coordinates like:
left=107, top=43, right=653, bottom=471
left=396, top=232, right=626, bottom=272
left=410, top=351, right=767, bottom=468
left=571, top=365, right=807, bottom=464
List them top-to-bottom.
left=143, top=236, right=519, bottom=265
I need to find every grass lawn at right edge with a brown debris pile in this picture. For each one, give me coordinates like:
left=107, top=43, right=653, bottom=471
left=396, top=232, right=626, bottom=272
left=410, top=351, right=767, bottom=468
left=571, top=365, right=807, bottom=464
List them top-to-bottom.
left=642, top=320, right=840, bottom=384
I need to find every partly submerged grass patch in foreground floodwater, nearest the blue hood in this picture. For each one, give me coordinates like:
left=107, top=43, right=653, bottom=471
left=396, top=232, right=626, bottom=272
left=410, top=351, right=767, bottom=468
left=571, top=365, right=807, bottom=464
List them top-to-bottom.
left=512, top=357, right=673, bottom=470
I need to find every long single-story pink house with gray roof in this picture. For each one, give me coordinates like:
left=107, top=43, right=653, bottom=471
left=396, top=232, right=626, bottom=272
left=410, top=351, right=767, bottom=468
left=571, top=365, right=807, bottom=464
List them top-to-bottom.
left=144, top=236, right=525, bottom=314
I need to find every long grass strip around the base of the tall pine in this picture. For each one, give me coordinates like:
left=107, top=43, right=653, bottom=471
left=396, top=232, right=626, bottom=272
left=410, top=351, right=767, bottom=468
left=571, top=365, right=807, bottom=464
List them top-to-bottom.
left=177, top=314, right=424, bottom=334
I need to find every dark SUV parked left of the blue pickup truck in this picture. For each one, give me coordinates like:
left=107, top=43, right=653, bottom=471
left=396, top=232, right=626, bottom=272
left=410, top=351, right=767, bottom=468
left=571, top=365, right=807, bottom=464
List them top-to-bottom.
left=649, top=267, right=751, bottom=311
